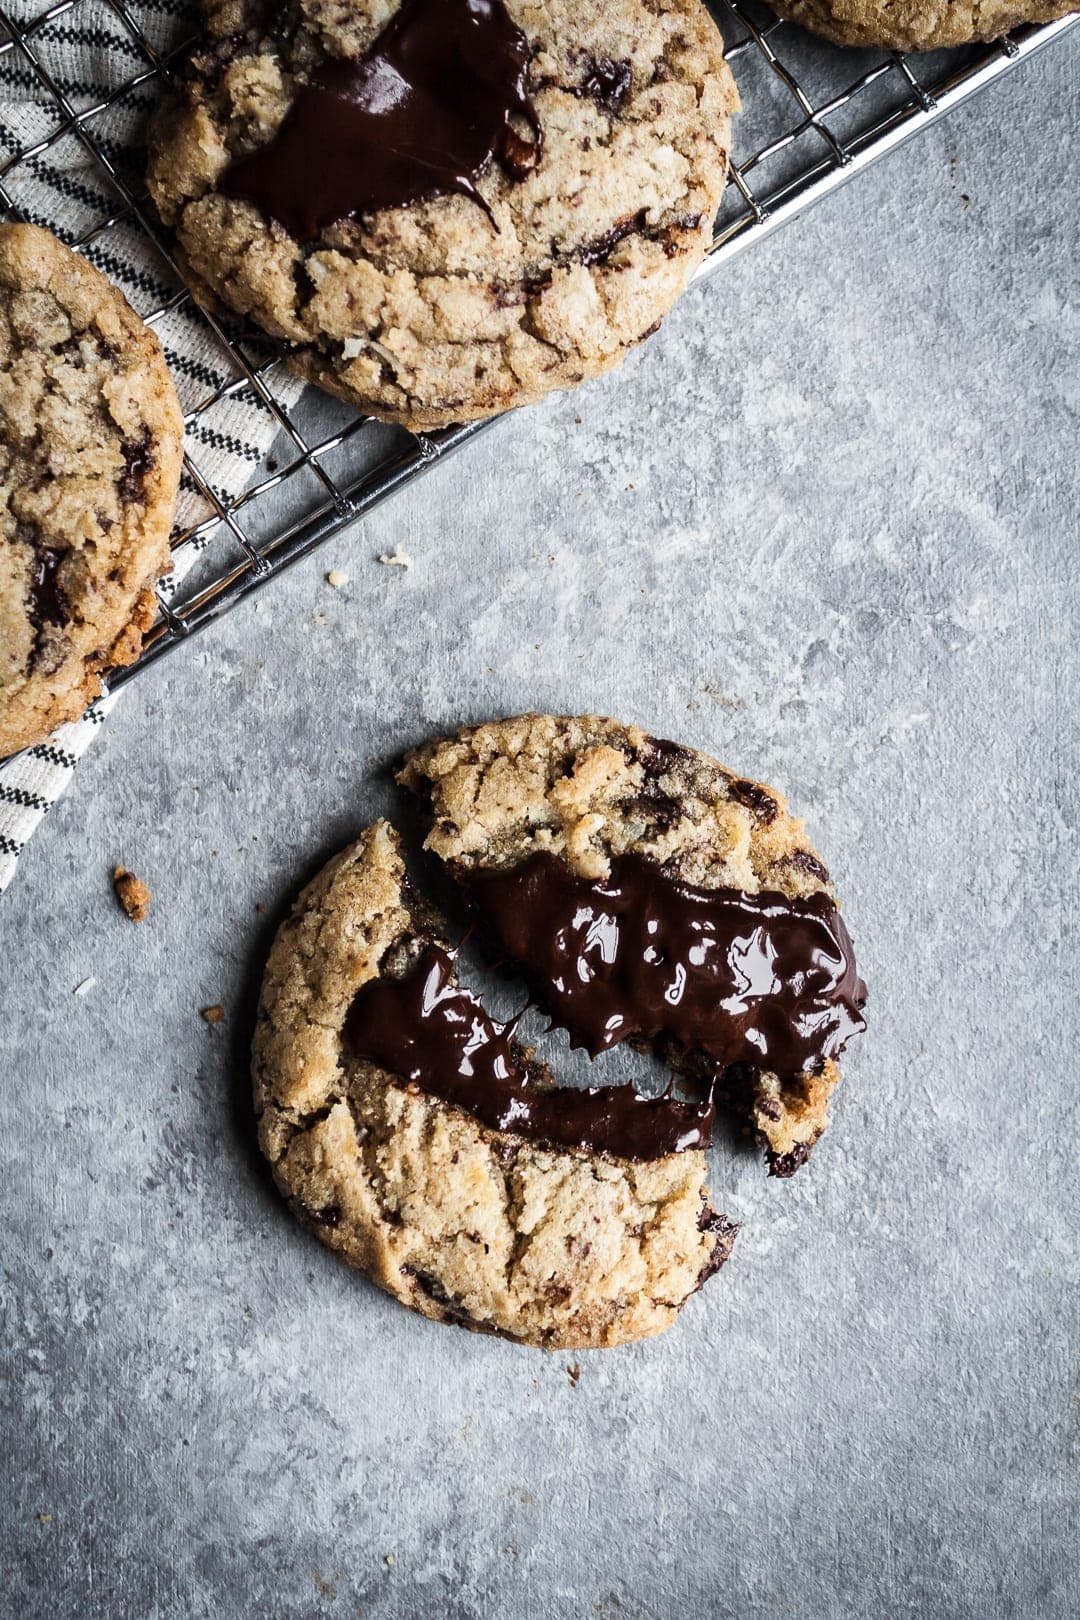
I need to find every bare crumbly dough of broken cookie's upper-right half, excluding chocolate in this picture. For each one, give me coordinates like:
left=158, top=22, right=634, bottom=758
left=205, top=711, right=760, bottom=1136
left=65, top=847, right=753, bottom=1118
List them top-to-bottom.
left=398, top=714, right=861, bottom=1176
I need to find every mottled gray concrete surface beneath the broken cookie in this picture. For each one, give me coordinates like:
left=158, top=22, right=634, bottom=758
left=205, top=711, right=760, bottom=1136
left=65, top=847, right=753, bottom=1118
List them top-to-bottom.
left=0, top=25, right=1080, bottom=1620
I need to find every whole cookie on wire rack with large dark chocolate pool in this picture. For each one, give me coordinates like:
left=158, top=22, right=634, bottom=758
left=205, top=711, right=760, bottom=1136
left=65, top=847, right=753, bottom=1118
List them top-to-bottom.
left=149, top=0, right=737, bottom=429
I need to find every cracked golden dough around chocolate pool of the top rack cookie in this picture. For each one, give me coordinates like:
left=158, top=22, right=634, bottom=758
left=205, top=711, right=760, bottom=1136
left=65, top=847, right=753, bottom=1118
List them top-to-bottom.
left=149, top=0, right=737, bottom=429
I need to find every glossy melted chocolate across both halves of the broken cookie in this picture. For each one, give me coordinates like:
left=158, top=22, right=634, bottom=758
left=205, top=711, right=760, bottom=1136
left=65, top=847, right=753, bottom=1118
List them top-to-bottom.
left=345, top=854, right=866, bottom=1160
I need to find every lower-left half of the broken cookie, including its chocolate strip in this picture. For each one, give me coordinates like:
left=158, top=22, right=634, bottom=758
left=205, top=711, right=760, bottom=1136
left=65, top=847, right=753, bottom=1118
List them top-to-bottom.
left=253, top=821, right=735, bottom=1349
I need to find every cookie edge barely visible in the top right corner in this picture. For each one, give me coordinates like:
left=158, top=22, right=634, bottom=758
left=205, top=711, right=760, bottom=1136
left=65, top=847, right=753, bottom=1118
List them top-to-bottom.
left=767, top=0, right=1077, bottom=52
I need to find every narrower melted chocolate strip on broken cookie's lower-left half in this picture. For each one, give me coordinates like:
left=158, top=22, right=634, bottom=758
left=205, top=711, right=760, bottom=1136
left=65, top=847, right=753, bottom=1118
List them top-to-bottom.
left=345, top=944, right=712, bottom=1160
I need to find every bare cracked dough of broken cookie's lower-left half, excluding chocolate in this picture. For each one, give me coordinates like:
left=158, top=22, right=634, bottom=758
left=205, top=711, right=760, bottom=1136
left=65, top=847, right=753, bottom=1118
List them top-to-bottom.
left=253, top=821, right=735, bottom=1349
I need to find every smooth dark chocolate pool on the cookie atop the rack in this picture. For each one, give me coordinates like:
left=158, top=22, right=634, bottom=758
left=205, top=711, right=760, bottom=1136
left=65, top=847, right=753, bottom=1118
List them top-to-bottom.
left=222, top=0, right=541, bottom=241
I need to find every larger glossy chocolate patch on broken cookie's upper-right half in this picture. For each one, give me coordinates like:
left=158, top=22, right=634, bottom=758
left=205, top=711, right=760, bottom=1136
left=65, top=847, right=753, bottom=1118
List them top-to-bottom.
left=468, top=852, right=866, bottom=1079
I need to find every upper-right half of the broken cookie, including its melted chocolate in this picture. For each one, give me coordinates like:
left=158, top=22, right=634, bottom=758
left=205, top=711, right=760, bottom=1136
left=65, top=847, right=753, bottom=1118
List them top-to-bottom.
left=400, top=714, right=866, bottom=1176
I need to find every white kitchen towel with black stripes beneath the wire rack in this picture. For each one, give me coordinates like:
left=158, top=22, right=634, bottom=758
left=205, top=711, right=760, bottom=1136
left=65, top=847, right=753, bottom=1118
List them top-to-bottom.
left=0, top=0, right=301, bottom=891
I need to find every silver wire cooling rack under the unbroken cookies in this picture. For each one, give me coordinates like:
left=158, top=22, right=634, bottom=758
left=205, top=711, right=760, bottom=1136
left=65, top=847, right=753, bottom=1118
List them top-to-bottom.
left=0, top=0, right=1080, bottom=687
